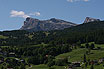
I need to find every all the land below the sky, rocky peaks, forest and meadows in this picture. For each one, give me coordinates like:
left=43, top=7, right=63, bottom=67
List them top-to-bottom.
left=0, top=17, right=104, bottom=69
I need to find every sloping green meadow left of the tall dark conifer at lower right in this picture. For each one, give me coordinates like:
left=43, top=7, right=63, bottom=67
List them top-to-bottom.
left=56, top=49, right=86, bottom=62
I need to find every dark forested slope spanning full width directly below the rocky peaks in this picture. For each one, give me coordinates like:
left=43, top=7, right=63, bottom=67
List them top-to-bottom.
left=0, top=21, right=104, bottom=46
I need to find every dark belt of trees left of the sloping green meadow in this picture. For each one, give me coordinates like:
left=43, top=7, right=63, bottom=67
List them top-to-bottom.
left=0, top=44, right=72, bottom=65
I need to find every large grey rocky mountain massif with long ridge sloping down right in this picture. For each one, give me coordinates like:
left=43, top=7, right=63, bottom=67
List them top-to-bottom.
left=20, top=17, right=77, bottom=31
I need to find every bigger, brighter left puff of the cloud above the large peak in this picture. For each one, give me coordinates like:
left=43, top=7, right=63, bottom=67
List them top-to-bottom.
left=10, top=10, right=30, bottom=18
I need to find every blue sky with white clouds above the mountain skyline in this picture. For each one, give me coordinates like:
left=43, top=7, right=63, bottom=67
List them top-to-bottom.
left=0, top=0, right=104, bottom=31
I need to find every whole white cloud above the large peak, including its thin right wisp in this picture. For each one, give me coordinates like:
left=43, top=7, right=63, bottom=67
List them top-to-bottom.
left=10, top=10, right=40, bottom=18
